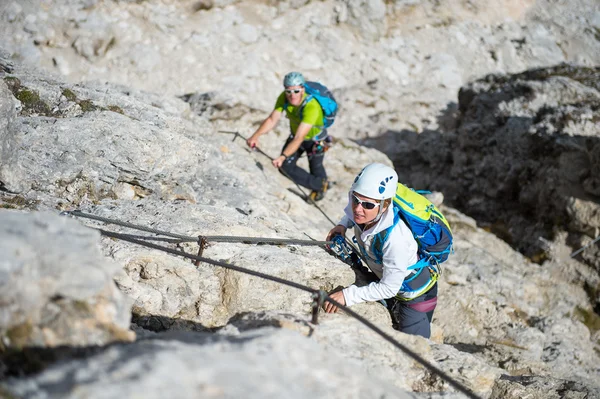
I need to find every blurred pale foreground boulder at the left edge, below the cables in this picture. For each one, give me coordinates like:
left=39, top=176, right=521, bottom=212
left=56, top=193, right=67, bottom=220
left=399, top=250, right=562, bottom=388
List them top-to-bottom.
left=0, top=210, right=135, bottom=350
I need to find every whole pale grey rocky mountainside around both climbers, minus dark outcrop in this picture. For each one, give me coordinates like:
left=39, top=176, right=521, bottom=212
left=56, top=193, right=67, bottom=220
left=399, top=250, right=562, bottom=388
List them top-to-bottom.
left=0, top=0, right=600, bottom=399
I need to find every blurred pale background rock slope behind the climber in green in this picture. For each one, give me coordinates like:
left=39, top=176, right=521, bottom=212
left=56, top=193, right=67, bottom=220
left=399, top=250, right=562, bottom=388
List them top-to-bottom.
left=0, top=0, right=600, bottom=139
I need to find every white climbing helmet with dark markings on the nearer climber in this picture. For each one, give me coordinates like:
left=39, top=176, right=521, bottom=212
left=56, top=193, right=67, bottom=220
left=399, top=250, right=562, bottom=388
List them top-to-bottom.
left=351, top=163, right=398, bottom=200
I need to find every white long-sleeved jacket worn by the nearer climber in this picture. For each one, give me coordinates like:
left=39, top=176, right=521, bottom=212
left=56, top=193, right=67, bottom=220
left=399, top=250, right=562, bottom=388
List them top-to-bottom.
left=338, top=198, right=418, bottom=306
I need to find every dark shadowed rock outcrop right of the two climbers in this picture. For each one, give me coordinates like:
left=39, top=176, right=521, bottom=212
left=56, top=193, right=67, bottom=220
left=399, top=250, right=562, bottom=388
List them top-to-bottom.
left=396, top=65, right=600, bottom=271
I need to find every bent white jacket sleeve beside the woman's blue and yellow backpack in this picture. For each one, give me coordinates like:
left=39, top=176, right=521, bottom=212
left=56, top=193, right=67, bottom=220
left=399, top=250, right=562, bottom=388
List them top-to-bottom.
left=343, top=221, right=418, bottom=306
